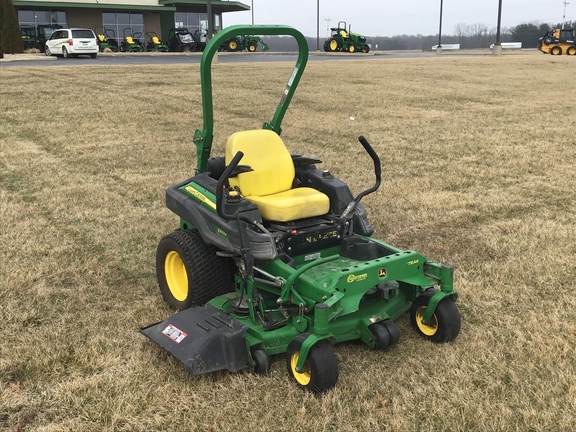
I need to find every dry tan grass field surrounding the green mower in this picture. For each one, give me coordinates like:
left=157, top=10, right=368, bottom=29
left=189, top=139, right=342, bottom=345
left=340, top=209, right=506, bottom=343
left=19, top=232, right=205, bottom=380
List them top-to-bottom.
left=0, top=55, right=576, bottom=432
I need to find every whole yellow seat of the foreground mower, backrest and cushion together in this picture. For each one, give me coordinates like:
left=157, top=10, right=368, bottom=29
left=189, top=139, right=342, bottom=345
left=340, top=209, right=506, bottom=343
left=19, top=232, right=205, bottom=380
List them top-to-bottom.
left=226, top=129, right=330, bottom=222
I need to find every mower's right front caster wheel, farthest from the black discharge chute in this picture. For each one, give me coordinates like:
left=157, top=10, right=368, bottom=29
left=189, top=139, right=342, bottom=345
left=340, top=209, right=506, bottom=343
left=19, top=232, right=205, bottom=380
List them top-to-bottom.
left=410, top=290, right=461, bottom=343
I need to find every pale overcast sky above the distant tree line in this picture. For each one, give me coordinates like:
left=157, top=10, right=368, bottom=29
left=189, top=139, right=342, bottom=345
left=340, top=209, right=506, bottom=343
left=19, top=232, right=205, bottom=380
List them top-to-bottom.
left=223, top=0, right=576, bottom=37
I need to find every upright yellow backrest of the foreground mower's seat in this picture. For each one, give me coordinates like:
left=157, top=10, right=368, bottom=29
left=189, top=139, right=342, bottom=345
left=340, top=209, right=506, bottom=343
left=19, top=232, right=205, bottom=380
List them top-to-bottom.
left=226, top=129, right=295, bottom=196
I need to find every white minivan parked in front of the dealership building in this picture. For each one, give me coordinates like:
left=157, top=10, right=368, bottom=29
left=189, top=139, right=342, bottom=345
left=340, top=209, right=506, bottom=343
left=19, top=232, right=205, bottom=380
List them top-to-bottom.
left=44, top=28, right=98, bottom=58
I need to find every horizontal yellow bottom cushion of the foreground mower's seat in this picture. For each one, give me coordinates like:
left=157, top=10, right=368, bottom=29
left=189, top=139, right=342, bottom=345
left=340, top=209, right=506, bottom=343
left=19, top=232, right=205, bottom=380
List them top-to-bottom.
left=245, top=187, right=330, bottom=222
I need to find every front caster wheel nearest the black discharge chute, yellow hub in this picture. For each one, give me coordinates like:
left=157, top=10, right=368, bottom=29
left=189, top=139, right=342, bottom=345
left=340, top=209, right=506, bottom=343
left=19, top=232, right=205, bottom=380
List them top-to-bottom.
left=286, top=333, right=338, bottom=393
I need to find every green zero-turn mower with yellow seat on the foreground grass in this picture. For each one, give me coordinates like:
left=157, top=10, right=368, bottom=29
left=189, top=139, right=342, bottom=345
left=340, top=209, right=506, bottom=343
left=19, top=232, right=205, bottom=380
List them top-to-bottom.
left=141, top=25, right=460, bottom=393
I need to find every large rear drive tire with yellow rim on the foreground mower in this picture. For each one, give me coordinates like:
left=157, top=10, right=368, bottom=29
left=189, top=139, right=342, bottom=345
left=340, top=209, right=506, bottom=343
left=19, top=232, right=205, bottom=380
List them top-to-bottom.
left=156, top=230, right=234, bottom=310
